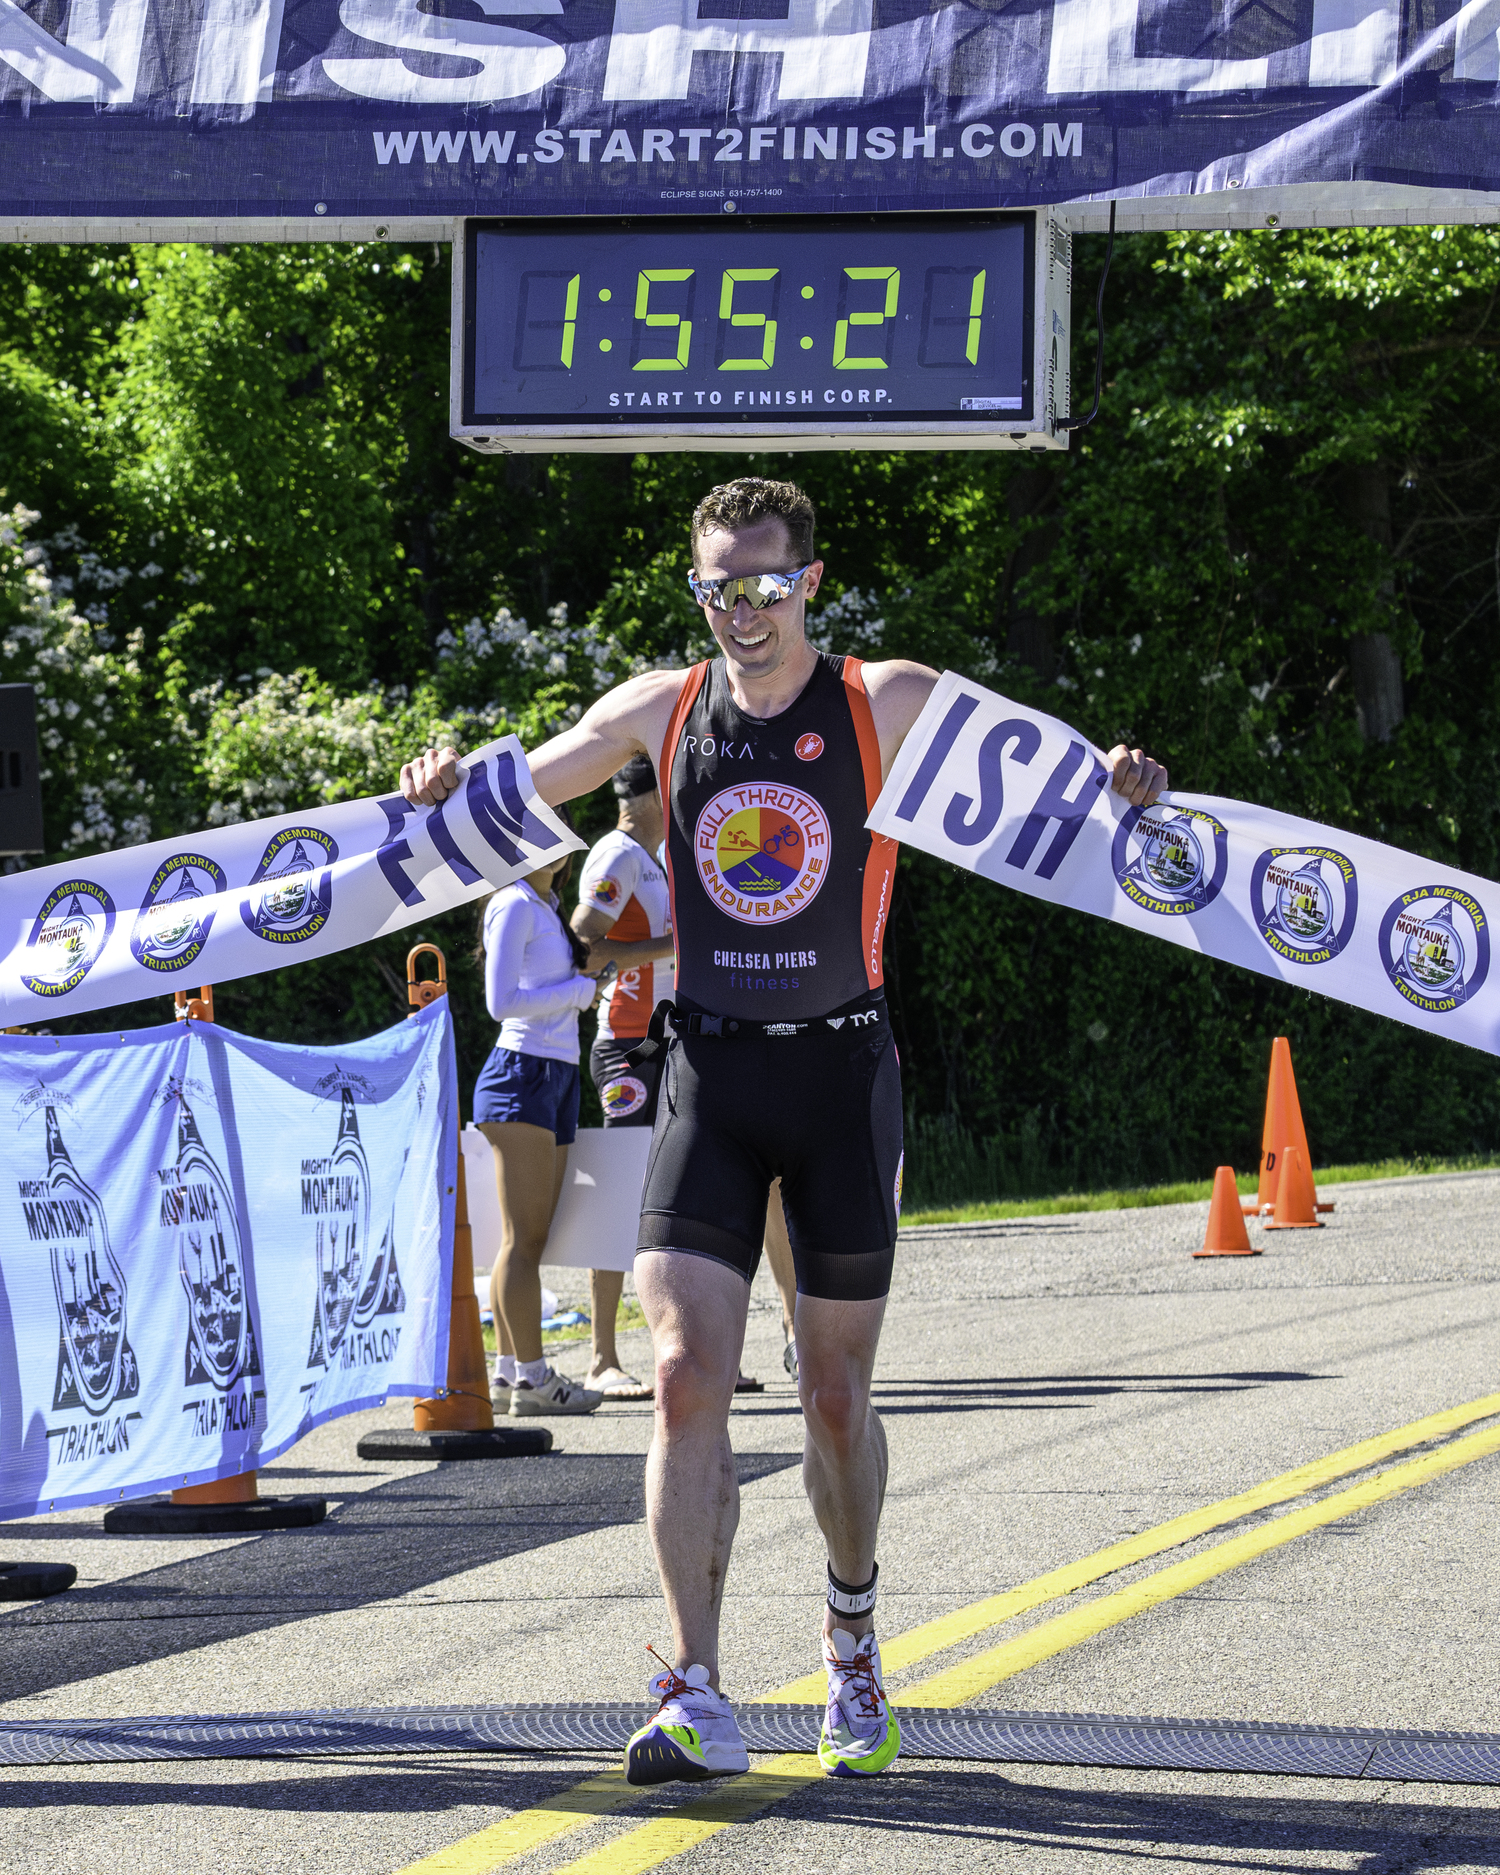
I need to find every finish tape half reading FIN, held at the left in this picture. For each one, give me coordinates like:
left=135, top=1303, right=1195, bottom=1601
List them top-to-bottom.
left=0, top=735, right=583, bottom=1028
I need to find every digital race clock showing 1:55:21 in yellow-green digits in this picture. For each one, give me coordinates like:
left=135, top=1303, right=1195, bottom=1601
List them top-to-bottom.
left=452, top=214, right=1071, bottom=452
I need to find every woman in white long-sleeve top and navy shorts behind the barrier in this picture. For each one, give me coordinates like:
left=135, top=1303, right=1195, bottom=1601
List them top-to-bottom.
left=474, top=855, right=604, bottom=1419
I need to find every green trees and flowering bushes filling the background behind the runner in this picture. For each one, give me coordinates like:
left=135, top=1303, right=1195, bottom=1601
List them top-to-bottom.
left=0, top=229, right=1500, bottom=1198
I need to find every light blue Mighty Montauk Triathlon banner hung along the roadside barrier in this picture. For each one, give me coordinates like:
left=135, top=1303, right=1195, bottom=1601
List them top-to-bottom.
left=0, top=998, right=458, bottom=1519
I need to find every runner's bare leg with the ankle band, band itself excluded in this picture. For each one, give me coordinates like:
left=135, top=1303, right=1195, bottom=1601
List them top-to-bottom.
left=797, top=1296, right=887, bottom=1635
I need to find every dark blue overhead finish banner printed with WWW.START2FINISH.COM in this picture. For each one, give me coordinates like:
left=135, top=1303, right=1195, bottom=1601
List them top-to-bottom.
left=0, top=0, right=1500, bottom=233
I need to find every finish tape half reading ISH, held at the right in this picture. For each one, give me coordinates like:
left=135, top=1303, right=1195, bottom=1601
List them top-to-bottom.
left=868, top=671, right=1500, bottom=1054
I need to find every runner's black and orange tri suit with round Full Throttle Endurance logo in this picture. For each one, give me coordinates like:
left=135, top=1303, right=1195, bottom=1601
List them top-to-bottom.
left=639, top=654, right=902, bottom=1301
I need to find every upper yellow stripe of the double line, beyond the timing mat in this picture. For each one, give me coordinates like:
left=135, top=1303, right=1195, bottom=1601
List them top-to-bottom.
left=761, top=1393, right=1500, bottom=1704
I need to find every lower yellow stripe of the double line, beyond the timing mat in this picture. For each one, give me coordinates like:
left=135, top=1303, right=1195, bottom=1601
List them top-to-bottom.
left=900, top=1427, right=1500, bottom=1706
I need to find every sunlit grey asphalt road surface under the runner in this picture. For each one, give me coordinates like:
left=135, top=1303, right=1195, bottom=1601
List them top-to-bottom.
left=0, top=1174, right=1500, bottom=1875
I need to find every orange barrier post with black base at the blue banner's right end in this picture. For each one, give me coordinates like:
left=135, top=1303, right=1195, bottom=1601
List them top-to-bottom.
left=356, top=943, right=551, bottom=1459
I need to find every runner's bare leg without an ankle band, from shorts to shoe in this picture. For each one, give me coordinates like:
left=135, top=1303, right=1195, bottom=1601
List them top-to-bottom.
left=636, top=1251, right=750, bottom=1688
